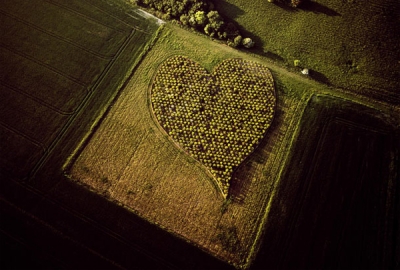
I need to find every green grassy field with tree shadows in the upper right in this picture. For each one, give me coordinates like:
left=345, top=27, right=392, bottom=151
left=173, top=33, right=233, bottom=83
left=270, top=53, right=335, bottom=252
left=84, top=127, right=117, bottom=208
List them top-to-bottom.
left=216, top=0, right=400, bottom=99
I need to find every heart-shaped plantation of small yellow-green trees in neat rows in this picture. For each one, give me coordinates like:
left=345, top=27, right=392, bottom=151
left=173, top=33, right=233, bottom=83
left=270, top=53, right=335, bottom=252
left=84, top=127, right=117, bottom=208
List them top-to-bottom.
left=151, top=56, right=276, bottom=198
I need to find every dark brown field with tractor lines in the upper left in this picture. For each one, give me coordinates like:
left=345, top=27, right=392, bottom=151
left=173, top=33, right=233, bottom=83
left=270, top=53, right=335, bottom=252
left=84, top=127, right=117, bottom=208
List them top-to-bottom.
left=0, top=0, right=158, bottom=178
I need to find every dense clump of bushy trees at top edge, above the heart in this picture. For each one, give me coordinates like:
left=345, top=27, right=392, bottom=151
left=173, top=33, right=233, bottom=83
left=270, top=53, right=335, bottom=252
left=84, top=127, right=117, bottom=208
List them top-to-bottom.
left=136, top=0, right=254, bottom=48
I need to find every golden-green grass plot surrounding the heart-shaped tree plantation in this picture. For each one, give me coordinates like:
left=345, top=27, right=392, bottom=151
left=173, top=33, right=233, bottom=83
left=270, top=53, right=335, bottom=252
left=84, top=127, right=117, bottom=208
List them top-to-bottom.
left=69, top=23, right=312, bottom=266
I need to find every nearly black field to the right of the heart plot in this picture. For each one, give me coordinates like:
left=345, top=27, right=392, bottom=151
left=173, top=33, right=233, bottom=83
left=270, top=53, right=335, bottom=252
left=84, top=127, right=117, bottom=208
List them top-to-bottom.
left=256, top=96, right=400, bottom=269
